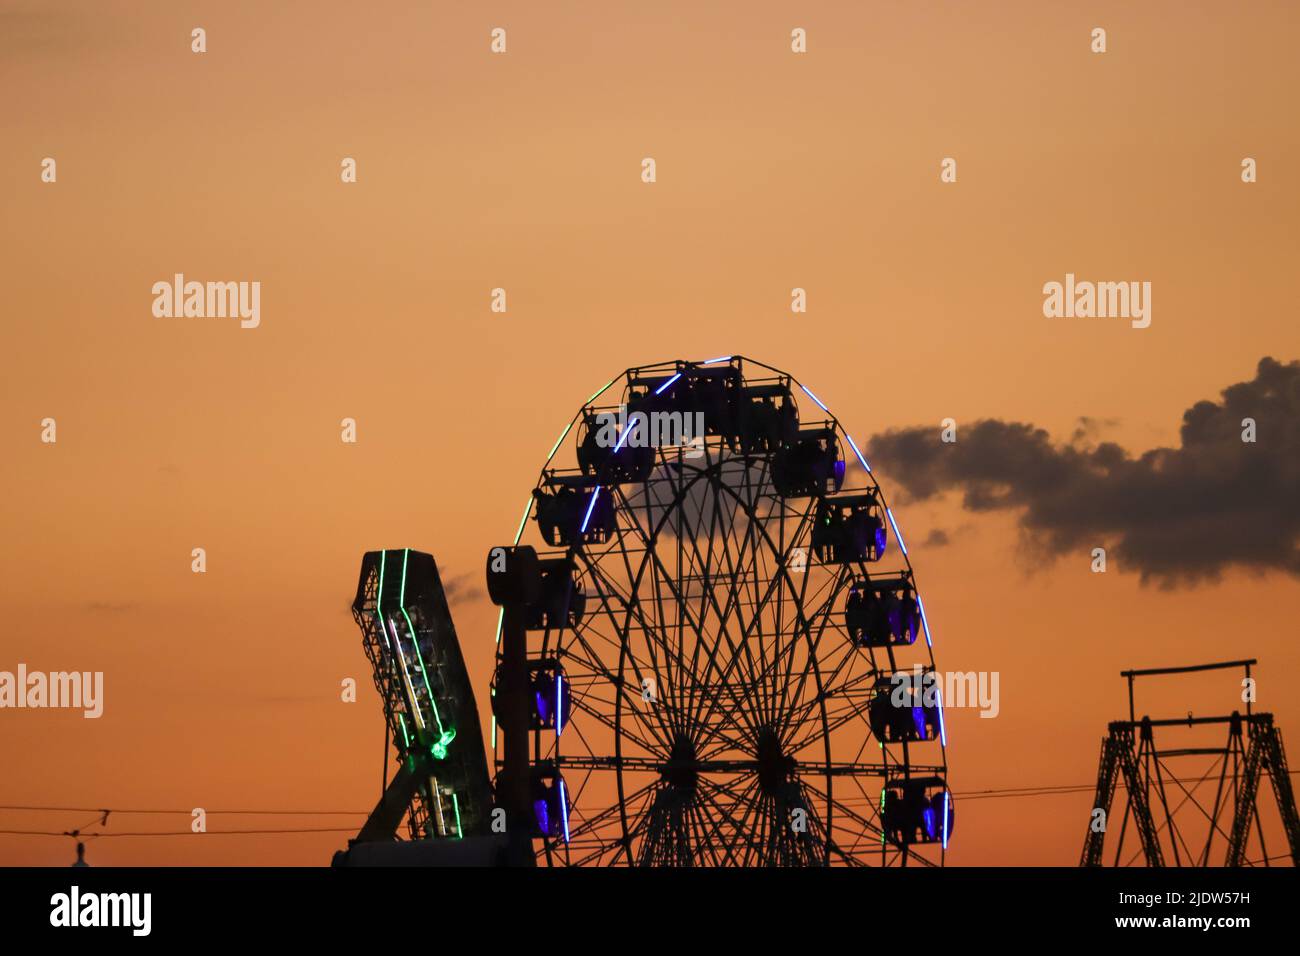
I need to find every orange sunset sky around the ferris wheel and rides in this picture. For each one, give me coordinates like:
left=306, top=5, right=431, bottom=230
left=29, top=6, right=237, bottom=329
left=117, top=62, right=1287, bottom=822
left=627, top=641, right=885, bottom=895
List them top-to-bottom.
left=0, top=1, right=1300, bottom=865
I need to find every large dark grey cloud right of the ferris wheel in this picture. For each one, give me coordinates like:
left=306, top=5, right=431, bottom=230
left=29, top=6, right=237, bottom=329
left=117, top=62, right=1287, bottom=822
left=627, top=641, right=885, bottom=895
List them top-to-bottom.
left=870, top=358, right=1300, bottom=587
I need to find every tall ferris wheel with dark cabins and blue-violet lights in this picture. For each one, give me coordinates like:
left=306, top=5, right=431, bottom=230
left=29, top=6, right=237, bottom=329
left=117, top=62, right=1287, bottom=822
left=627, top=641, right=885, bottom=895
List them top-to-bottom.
left=489, top=356, right=954, bottom=866
